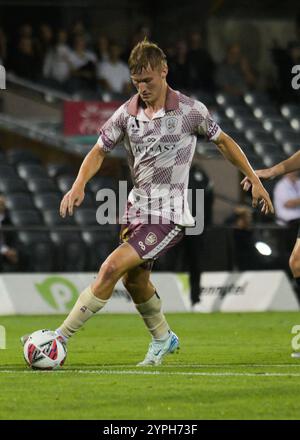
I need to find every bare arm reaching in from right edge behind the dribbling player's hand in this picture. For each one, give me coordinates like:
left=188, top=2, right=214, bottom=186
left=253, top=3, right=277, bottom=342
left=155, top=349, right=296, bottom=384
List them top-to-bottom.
left=241, top=150, right=300, bottom=191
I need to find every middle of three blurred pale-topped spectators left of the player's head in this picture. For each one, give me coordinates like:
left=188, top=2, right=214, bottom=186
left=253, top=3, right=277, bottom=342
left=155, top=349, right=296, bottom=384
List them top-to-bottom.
left=68, top=35, right=97, bottom=92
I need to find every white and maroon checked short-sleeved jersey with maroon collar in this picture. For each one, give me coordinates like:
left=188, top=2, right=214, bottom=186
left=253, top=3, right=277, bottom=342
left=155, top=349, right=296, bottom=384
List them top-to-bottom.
left=98, top=88, right=221, bottom=226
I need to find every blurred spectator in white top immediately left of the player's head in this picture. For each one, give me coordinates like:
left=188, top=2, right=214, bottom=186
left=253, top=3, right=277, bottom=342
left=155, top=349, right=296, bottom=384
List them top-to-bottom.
left=97, top=43, right=132, bottom=95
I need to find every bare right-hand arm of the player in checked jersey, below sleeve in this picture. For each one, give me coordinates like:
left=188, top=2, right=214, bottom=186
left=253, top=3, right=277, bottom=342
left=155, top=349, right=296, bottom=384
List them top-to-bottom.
left=213, top=131, right=274, bottom=214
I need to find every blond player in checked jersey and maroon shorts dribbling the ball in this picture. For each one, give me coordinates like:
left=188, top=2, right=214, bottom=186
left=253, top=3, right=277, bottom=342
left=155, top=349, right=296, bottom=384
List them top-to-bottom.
left=22, top=40, right=273, bottom=366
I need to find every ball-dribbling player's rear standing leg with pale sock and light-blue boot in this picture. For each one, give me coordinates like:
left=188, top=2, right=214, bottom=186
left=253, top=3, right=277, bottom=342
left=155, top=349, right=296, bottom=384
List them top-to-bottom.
left=122, top=263, right=179, bottom=366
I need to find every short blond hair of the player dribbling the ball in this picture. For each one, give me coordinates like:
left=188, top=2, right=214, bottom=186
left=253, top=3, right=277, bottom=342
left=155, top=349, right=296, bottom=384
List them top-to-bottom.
left=128, top=38, right=167, bottom=74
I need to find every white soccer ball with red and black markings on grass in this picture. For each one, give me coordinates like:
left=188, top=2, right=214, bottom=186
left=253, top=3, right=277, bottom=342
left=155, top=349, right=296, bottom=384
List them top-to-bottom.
left=24, top=330, right=67, bottom=370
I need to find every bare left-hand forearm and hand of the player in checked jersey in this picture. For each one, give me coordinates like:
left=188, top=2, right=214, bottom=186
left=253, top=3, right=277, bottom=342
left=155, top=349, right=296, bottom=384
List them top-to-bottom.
left=60, top=143, right=105, bottom=217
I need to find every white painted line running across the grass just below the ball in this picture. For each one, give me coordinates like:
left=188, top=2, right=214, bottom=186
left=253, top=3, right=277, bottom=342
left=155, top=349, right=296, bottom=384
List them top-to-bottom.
left=0, top=370, right=300, bottom=377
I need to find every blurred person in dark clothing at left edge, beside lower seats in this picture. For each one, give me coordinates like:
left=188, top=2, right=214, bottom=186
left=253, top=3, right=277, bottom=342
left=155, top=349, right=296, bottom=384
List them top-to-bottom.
left=0, top=195, right=19, bottom=271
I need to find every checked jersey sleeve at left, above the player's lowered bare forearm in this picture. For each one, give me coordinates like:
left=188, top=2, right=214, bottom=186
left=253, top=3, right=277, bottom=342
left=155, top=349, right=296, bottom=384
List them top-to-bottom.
left=97, top=104, right=127, bottom=153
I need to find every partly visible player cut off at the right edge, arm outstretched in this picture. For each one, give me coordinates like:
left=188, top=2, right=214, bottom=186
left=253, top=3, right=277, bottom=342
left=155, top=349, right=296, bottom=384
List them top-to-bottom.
left=241, top=150, right=300, bottom=359
